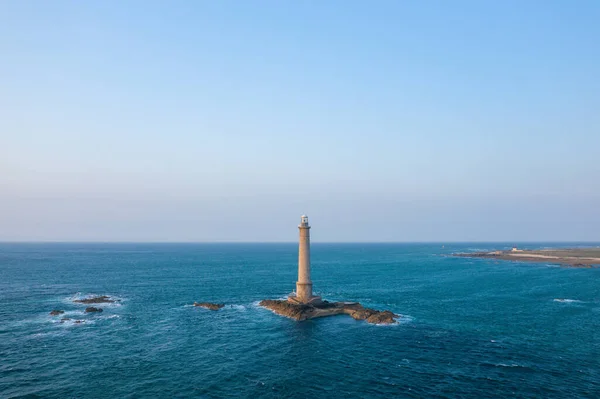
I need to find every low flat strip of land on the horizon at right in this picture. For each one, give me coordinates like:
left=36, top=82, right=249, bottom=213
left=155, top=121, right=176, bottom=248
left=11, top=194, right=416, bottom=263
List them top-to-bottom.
left=452, top=248, right=600, bottom=268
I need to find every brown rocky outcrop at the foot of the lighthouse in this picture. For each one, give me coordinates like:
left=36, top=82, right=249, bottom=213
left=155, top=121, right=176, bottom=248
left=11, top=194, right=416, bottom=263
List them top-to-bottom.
left=259, top=299, right=400, bottom=324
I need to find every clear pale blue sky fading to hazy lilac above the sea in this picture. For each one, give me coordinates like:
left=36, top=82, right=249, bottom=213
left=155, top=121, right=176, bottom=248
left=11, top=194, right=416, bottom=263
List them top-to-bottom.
left=0, top=0, right=600, bottom=242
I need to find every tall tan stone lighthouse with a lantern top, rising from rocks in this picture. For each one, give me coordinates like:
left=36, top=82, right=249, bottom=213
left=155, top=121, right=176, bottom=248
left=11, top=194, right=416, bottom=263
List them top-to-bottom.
left=288, top=215, right=321, bottom=304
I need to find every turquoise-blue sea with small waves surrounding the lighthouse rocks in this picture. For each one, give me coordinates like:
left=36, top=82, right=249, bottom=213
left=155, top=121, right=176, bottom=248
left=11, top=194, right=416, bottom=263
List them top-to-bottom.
left=0, top=243, right=600, bottom=398
